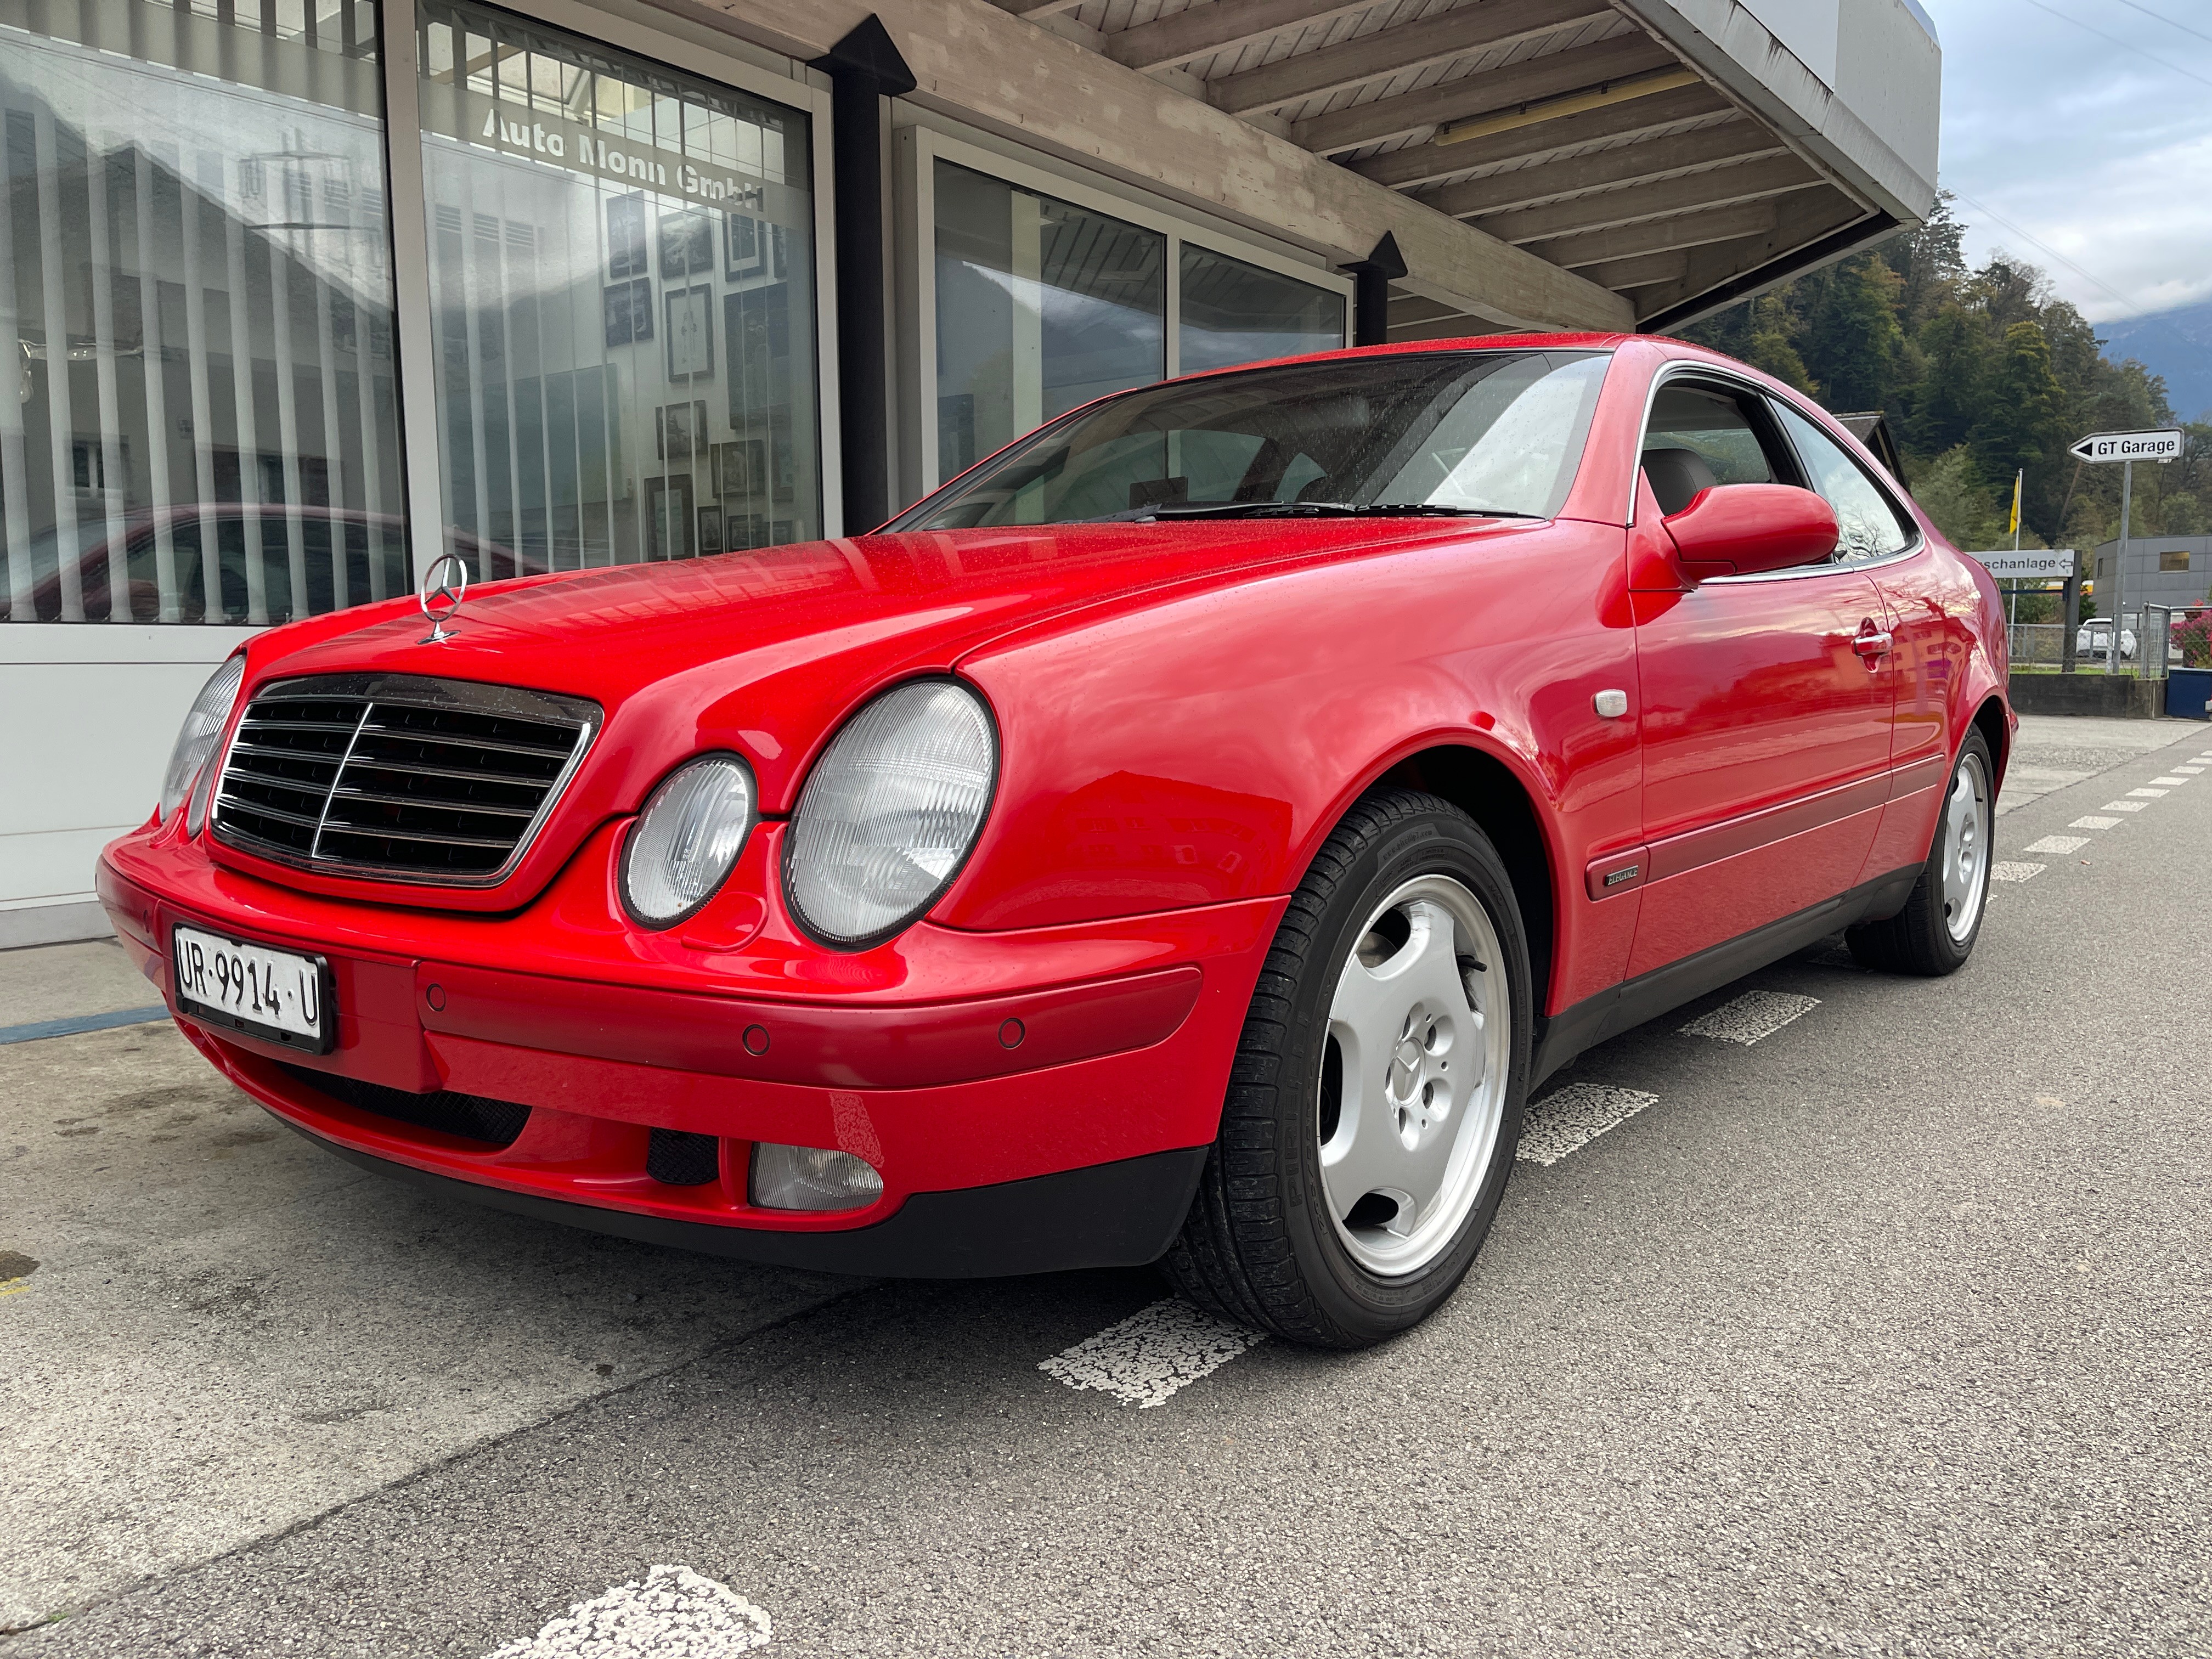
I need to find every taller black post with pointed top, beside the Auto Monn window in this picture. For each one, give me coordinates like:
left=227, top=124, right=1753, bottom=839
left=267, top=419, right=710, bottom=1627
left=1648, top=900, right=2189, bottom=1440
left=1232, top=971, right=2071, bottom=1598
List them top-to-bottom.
left=814, top=13, right=913, bottom=535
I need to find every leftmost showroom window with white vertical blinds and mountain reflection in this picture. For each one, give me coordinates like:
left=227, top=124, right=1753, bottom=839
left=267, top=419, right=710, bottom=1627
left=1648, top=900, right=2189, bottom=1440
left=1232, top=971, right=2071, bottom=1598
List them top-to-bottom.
left=0, top=0, right=411, bottom=624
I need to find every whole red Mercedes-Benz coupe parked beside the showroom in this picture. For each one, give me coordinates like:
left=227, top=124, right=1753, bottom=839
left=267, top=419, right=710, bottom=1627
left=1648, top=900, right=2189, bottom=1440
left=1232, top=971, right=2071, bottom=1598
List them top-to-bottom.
left=99, top=336, right=2013, bottom=1347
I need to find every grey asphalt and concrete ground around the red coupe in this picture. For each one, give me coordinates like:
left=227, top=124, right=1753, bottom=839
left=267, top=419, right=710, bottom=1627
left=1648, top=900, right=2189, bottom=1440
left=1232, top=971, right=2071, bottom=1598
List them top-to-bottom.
left=0, top=721, right=2212, bottom=1659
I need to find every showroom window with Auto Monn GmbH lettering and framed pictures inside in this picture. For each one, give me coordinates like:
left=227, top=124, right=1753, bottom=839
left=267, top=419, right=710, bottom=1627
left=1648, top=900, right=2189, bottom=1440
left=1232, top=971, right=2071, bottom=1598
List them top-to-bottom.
left=420, top=0, right=821, bottom=577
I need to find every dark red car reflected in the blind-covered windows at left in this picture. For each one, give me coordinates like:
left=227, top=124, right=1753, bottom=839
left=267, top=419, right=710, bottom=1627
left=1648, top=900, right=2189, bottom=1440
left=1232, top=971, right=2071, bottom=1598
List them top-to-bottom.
left=0, top=502, right=524, bottom=624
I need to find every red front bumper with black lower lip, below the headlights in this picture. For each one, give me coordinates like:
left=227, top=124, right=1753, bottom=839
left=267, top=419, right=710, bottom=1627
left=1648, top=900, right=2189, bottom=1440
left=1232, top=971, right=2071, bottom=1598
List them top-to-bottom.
left=99, top=825, right=1281, bottom=1276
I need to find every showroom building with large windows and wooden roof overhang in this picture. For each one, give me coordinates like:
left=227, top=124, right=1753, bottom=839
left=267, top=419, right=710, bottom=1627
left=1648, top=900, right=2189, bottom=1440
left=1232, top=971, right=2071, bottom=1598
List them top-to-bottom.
left=0, top=0, right=1940, bottom=946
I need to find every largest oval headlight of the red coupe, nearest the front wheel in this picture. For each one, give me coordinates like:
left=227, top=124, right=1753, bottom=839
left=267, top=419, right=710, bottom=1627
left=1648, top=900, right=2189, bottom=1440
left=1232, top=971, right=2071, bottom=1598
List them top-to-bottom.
left=783, top=679, right=997, bottom=945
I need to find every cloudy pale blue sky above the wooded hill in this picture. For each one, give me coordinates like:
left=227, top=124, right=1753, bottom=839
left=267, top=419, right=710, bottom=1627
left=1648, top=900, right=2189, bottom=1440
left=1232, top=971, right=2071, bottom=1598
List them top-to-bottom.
left=1922, top=0, right=2212, bottom=321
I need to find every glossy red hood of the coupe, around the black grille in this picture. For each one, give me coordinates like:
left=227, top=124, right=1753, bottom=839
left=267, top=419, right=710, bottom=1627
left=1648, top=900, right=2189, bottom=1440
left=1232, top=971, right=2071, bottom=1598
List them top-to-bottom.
left=220, top=520, right=1504, bottom=909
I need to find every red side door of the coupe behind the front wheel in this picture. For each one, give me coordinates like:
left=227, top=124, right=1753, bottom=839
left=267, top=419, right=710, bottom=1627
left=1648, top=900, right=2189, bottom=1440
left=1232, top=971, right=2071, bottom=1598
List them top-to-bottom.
left=1628, top=367, right=1895, bottom=980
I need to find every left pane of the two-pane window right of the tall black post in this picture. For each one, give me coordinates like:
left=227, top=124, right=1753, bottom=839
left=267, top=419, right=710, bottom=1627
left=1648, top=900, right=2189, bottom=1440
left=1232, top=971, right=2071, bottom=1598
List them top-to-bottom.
left=934, top=161, right=1168, bottom=478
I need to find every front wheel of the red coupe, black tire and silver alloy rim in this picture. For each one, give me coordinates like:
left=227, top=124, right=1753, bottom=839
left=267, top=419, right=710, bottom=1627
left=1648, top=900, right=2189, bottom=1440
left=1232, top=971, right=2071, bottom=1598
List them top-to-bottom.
left=1161, top=787, right=1531, bottom=1350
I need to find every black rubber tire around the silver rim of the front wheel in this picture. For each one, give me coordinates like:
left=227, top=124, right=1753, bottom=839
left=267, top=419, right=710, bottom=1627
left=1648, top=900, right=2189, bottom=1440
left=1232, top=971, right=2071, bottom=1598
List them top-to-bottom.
left=1276, top=801, right=1533, bottom=1342
